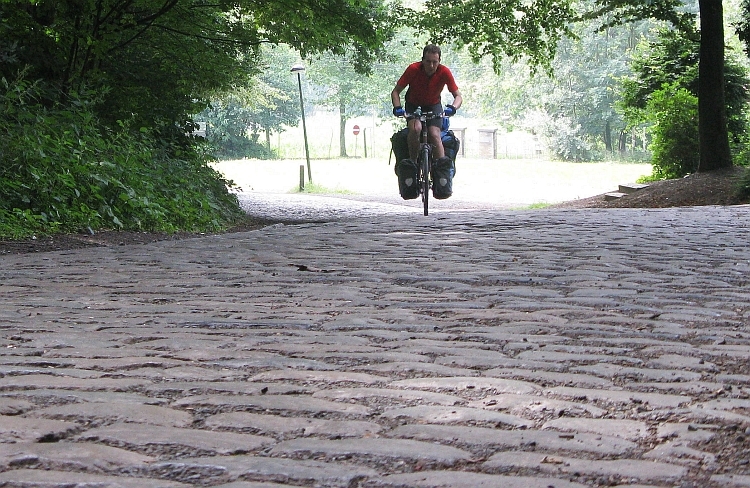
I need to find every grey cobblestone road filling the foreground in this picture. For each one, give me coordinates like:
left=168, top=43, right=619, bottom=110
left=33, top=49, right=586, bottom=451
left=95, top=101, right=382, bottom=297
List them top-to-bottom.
left=0, top=195, right=750, bottom=488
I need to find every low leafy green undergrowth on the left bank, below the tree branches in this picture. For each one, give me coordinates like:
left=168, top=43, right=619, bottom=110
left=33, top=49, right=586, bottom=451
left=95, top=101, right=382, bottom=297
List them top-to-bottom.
left=0, top=74, right=240, bottom=237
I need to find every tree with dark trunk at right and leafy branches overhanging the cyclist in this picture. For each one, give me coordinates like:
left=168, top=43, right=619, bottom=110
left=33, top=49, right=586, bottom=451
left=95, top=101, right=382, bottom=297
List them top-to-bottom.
left=422, top=0, right=732, bottom=171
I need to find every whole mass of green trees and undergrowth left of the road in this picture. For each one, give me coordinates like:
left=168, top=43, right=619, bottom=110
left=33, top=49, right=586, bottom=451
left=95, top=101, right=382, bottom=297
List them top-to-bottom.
left=0, top=0, right=397, bottom=236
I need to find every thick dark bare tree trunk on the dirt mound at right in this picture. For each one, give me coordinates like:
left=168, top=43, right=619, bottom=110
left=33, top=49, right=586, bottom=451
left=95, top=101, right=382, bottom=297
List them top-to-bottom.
left=698, top=0, right=732, bottom=172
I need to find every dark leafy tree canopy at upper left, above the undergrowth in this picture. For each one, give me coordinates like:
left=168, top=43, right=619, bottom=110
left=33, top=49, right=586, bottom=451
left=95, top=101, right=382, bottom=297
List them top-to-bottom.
left=0, top=0, right=394, bottom=132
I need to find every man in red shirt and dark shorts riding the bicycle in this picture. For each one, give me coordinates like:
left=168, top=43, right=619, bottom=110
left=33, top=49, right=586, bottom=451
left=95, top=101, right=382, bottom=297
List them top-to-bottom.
left=391, top=44, right=463, bottom=161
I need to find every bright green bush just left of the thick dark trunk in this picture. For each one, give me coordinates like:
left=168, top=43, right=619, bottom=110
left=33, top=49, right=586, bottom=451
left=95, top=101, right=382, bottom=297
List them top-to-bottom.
left=646, top=84, right=700, bottom=180
